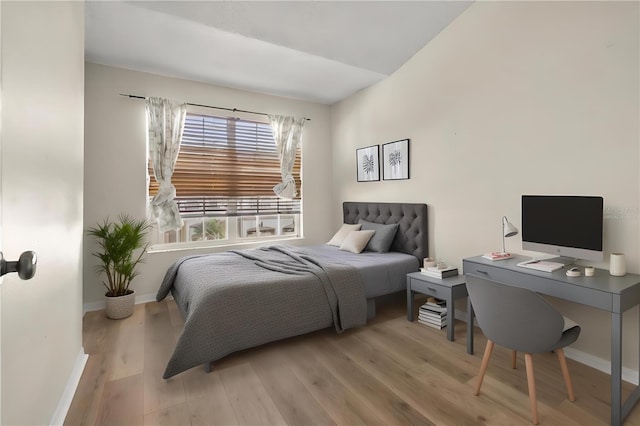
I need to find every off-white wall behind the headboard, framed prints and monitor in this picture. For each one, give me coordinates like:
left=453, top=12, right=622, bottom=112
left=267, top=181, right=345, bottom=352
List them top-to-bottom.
left=332, top=2, right=640, bottom=370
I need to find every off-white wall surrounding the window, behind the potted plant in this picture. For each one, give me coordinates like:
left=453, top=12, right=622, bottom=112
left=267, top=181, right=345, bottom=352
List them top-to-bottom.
left=84, top=63, right=332, bottom=308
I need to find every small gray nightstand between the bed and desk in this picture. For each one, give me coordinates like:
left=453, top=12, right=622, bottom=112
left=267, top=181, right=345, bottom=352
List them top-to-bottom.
left=407, top=272, right=468, bottom=341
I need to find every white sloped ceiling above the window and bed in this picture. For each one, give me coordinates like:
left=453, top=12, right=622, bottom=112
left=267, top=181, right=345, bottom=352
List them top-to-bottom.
left=85, top=1, right=472, bottom=104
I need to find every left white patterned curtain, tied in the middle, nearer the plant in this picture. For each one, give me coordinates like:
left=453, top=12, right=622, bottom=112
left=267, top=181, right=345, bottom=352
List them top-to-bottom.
left=146, top=98, right=187, bottom=232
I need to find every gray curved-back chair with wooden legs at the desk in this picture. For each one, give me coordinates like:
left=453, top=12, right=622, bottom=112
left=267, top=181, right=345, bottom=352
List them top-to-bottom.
left=465, top=274, right=580, bottom=425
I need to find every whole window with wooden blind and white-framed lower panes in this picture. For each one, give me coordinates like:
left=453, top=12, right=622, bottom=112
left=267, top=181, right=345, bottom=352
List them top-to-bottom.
left=149, top=113, right=302, bottom=245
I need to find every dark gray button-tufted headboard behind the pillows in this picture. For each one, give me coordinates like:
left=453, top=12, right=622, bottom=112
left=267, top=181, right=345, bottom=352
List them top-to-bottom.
left=342, top=201, right=429, bottom=264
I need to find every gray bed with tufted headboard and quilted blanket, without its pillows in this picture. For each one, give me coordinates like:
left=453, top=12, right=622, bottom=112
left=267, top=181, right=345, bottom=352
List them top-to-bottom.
left=156, top=202, right=428, bottom=379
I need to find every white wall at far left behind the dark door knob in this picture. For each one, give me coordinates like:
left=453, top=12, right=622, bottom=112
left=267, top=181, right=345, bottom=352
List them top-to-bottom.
left=0, top=1, right=84, bottom=425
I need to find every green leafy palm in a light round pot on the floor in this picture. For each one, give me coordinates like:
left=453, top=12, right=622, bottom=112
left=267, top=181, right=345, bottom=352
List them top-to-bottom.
left=87, top=214, right=151, bottom=319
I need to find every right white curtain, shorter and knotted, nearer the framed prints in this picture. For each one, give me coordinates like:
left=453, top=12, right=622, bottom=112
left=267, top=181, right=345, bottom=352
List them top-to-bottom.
left=269, top=115, right=305, bottom=200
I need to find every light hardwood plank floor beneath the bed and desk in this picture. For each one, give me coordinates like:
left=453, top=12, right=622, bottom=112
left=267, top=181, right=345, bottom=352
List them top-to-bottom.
left=65, top=300, right=640, bottom=425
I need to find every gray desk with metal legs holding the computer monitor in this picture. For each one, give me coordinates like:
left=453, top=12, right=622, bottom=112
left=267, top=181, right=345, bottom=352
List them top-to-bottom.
left=462, top=255, right=640, bottom=425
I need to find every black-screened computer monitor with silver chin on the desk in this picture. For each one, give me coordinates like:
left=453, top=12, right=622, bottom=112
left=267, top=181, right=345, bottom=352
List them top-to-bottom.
left=522, top=195, right=604, bottom=264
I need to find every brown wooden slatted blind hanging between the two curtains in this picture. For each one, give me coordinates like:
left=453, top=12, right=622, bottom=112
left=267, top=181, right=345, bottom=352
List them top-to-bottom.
left=149, top=114, right=302, bottom=217
